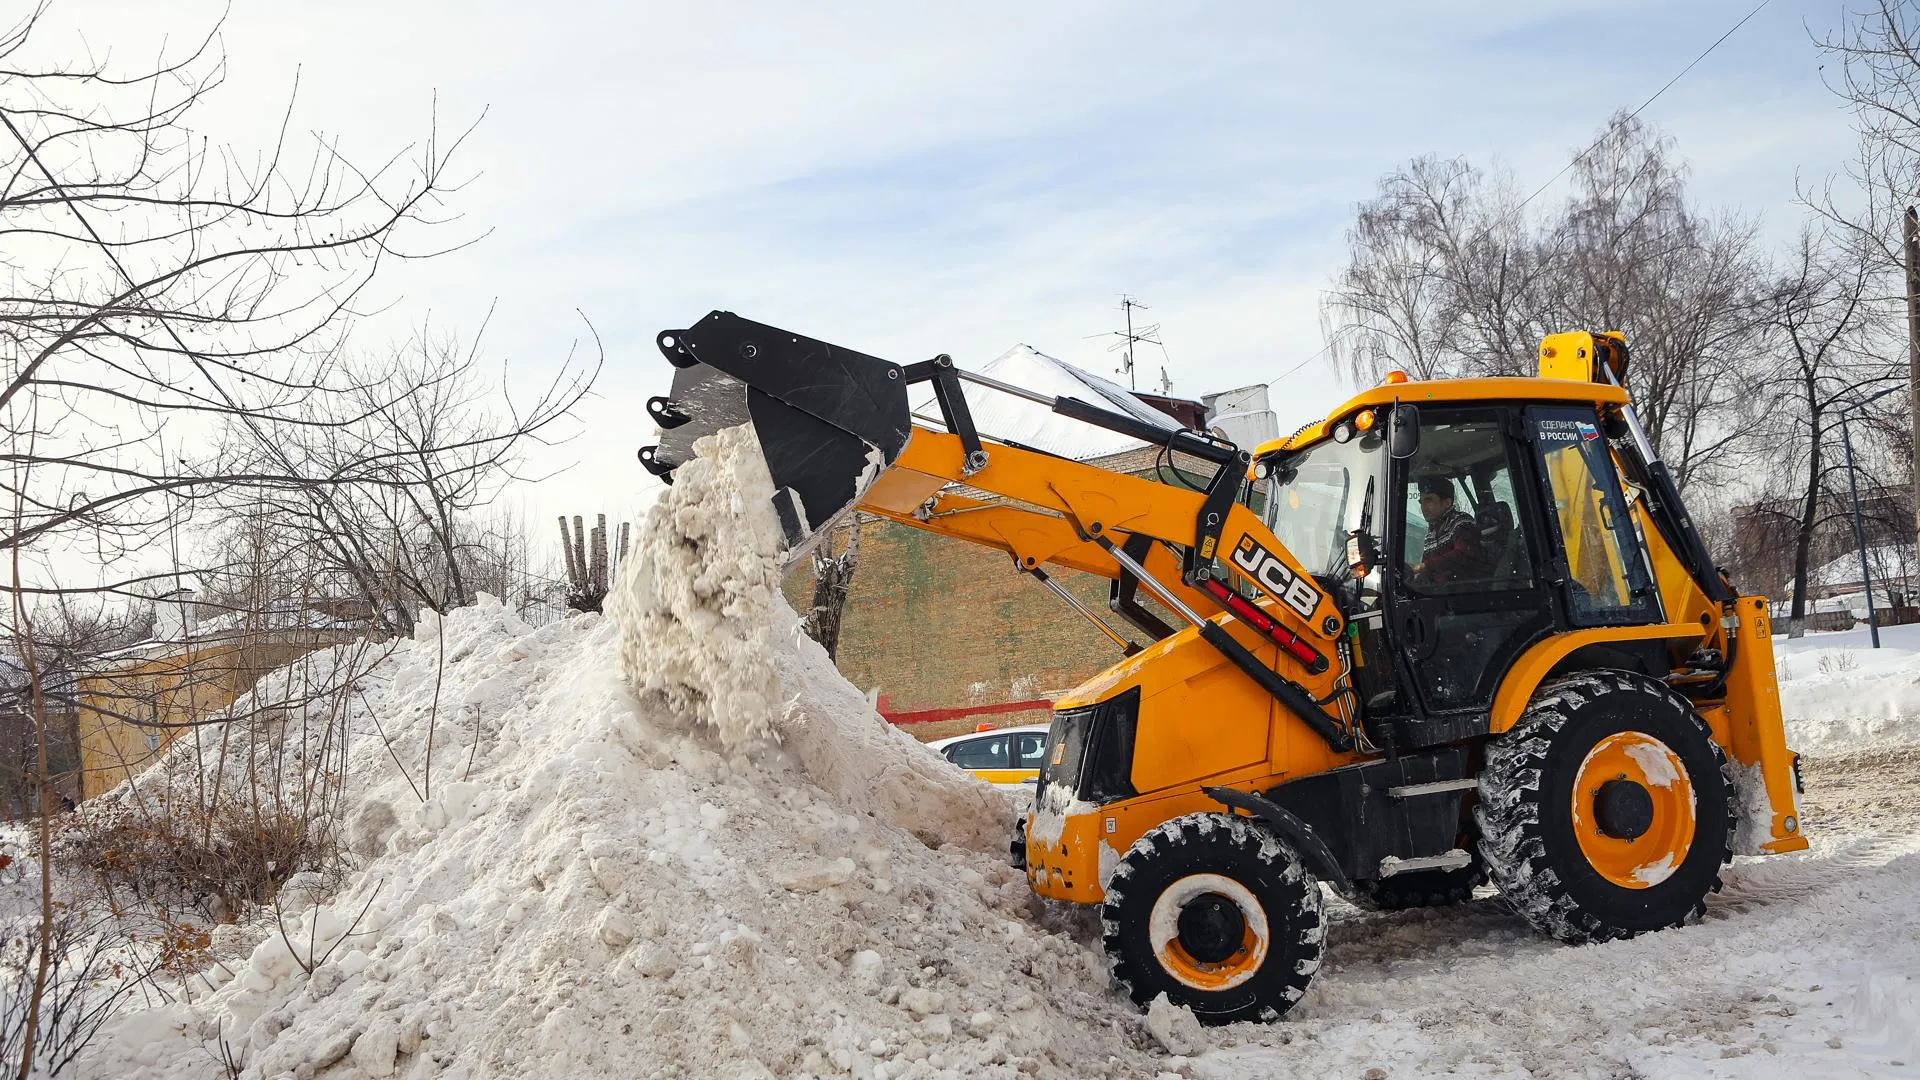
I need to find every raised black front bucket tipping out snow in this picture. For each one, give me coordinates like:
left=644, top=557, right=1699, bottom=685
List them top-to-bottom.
left=639, top=311, right=912, bottom=545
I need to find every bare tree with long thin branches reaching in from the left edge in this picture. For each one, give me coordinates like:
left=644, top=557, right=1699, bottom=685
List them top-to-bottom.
left=0, top=2, right=591, bottom=1076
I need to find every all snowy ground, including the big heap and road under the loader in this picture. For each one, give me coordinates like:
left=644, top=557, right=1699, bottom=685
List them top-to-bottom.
left=26, top=451, right=1920, bottom=1080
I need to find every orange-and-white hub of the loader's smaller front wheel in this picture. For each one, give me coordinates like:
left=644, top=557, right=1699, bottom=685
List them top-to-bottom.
left=1146, top=874, right=1267, bottom=990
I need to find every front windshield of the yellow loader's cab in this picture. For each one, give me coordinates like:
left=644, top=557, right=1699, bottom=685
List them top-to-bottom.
left=1265, top=434, right=1386, bottom=580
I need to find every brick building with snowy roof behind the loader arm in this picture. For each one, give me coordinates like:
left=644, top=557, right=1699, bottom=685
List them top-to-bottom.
left=787, top=346, right=1273, bottom=738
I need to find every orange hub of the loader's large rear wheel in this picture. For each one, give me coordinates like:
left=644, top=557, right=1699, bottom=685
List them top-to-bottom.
left=1572, top=732, right=1693, bottom=890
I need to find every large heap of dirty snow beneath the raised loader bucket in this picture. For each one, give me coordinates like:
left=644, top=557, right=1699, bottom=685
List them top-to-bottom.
left=86, top=424, right=1158, bottom=1080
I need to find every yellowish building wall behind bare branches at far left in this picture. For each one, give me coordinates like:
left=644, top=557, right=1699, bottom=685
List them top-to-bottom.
left=77, top=632, right=348, bottom=801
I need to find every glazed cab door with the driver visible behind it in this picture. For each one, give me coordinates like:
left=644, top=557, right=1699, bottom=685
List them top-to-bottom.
left=1386, top=405, right=1557, bottom=746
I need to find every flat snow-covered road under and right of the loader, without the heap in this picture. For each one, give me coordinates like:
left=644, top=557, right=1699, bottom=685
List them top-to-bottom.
left=1175, top=749, right=1920, bottom=1080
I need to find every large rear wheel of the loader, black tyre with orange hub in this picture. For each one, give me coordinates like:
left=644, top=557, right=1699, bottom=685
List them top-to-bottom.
left=1476, top=671, right=1736, bottom=944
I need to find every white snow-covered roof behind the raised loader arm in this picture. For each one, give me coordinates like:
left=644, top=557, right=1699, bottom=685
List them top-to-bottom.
left=914, top=346, right=1181, bottom=461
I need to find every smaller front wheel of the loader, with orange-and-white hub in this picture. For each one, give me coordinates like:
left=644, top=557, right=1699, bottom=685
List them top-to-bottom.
left=1100, top=813, right=1327, bottom=1024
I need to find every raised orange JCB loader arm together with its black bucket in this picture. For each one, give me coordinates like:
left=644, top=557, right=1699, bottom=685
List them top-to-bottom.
left=639, top=311, right=1354, bottom=749
